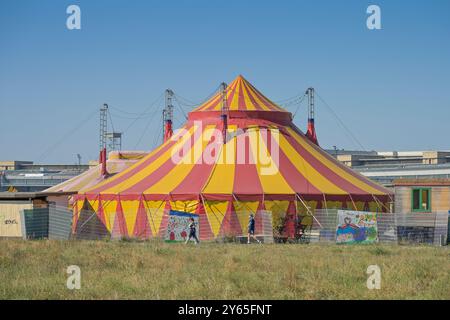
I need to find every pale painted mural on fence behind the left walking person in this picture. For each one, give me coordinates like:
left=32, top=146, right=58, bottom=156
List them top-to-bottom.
left=165, top=210, right=200, bottom=242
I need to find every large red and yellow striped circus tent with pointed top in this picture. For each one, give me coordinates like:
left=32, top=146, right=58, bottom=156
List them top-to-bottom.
left=74, top=76, right=391, bottom=239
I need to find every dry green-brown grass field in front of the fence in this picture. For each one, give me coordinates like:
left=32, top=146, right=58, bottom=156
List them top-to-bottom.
left=0, top=240, right=450, bottom=299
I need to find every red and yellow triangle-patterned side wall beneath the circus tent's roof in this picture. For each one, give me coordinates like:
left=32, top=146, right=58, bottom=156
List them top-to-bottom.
left=73, top=197, right=389, bottom=240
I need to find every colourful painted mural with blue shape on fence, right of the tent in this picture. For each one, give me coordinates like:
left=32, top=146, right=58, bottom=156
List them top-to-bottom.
left=336, top=210, right=378, bottom=243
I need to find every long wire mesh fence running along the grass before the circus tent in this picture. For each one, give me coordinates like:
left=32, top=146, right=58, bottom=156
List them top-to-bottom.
left=0, top=205, right=450, bottom=246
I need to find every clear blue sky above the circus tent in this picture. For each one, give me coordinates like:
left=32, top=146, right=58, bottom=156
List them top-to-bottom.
left=0, top=0, right=450, bottom=163
